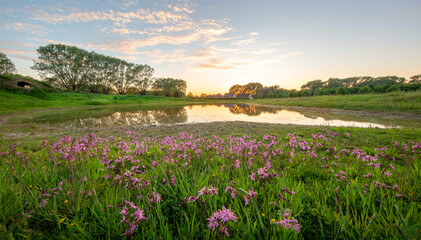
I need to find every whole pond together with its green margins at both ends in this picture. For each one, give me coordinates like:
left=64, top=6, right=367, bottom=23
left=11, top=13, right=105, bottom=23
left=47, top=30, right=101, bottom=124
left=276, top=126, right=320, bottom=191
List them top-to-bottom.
left=15, top=104, right=421, bottom=129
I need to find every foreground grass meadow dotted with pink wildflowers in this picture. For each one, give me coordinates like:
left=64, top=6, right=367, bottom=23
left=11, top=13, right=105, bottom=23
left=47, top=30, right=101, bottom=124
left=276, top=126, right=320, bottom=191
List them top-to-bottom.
left=0, top=127, right=421, bottom=239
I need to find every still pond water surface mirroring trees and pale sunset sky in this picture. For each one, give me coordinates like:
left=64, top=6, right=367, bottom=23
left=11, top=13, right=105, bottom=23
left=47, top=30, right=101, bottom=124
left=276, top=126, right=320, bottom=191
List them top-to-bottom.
left=37, top=104, right=399, bottom=129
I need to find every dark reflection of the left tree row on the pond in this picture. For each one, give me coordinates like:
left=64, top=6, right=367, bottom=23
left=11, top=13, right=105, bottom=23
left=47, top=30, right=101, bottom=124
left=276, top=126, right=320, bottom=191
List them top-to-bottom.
left=51, top=107, right=188, bottom=129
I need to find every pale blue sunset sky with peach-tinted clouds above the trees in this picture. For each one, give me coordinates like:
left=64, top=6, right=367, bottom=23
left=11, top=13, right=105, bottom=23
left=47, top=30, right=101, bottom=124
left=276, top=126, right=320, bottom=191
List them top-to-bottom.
left=0, top=0, right=421, bottom=95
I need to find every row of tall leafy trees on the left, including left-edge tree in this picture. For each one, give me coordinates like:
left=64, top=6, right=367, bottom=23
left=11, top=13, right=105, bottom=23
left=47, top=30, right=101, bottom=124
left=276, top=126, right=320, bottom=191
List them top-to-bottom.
left=0, top=44, right=187, bottom=97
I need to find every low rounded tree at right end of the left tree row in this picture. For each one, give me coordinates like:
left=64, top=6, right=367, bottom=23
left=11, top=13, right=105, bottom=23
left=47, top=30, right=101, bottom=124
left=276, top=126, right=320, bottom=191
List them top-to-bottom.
left=152, top=78, right=187, bottom=97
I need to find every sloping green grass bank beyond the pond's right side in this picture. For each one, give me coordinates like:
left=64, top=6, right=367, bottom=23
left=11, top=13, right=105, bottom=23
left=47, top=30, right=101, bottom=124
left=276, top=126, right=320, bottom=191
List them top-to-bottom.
left=252, top=91, right=421, bottom=114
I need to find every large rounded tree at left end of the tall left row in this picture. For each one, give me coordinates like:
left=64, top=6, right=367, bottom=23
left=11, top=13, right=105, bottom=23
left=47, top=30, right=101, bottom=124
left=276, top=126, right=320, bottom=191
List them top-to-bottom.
left=31, top=44, right=90, bottom=90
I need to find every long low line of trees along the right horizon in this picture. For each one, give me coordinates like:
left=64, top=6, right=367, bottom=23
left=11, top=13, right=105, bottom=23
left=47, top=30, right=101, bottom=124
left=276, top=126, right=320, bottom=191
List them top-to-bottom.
left=229, top=74, right=421, bottom=98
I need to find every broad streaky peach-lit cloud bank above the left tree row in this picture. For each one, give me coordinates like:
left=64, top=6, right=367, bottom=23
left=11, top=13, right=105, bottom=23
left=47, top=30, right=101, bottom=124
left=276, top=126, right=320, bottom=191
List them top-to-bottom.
left=9, top=0, right=301, bottom=71
